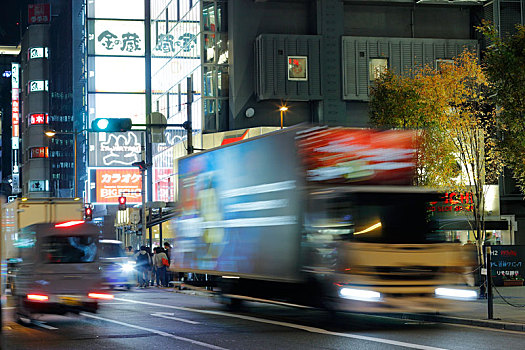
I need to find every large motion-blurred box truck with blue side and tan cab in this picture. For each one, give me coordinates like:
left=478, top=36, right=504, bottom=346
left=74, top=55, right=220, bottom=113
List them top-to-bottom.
left=170, top=126, right=477, bottom=313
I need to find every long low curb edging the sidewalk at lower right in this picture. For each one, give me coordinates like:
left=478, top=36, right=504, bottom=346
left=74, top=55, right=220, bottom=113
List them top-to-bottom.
left=390, top=314, right=525, bottom=332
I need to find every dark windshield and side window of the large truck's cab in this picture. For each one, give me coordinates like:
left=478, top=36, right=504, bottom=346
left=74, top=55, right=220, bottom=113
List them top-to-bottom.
left=306, top=192, right=444, bottom=244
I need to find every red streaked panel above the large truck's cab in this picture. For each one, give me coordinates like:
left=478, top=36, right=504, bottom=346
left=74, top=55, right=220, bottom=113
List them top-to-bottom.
left=298, top=128, right=417, bottom=185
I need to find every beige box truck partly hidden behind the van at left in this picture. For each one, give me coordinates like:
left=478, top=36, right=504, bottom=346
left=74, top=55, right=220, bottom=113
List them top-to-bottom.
left=1, top=198, right=84, bottom=294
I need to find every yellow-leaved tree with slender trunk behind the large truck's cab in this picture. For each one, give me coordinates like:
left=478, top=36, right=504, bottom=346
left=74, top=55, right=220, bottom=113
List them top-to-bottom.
left=370, top=51, right=502, bottom=263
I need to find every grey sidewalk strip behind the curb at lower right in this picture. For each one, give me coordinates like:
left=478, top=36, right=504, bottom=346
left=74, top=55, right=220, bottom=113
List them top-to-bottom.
left=403, top=286, right=525, bottom=332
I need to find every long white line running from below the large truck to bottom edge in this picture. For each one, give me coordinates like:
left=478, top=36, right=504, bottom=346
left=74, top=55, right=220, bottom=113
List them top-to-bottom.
left=115, top=298, right=444, bottom=350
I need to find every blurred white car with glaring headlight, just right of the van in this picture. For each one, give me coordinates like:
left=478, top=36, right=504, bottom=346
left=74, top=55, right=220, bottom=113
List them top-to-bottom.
left=99, top=239, right=135, bottom=289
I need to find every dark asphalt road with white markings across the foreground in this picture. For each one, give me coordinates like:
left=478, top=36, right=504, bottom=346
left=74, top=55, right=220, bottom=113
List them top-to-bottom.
left=2, top=288, right=525, bottom=350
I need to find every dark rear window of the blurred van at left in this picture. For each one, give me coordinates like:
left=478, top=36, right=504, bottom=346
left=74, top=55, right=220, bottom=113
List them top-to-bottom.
left=41, top=236, right=97, bottom=264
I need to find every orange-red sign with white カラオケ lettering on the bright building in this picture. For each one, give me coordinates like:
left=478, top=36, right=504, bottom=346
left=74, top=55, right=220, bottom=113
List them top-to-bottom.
left=96, top=168, right=142, bottom=204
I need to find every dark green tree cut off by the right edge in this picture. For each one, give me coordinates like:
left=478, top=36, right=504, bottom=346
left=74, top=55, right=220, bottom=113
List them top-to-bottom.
left=478, top=22, right=525, bottom=193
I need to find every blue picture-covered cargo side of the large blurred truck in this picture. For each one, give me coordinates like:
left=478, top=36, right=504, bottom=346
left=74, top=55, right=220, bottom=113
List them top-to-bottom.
left=171, top=132, right=303, bottom=280
